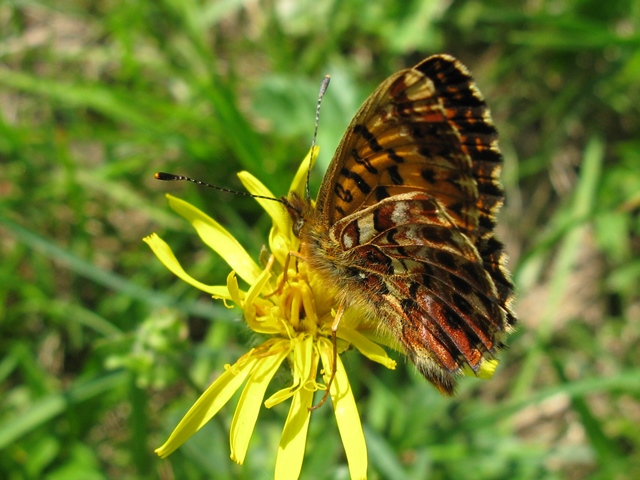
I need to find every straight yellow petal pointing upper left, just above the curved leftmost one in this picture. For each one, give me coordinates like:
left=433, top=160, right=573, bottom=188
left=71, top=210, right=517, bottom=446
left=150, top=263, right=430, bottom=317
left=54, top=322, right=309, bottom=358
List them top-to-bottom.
left=167, top=195, right=262, bottom=284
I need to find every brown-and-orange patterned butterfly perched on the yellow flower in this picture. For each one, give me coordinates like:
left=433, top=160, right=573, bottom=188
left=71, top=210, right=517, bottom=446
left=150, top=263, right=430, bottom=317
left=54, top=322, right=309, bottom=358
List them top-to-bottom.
left=284, top=55, right=516, bottom=395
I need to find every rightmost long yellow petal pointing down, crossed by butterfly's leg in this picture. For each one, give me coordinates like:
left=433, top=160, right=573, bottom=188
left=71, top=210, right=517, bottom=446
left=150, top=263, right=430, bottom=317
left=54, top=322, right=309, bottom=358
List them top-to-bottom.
left=318, top=338, right=368, bottom=479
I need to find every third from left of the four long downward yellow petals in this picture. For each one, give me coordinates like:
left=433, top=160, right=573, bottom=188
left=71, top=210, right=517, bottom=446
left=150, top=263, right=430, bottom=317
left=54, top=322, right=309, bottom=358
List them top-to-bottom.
left=274, top=337, right=318, bottom=480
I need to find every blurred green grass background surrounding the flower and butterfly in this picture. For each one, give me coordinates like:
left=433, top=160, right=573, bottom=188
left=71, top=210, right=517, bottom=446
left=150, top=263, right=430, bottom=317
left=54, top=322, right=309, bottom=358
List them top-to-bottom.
left=0, top=0, right=640, bottom=480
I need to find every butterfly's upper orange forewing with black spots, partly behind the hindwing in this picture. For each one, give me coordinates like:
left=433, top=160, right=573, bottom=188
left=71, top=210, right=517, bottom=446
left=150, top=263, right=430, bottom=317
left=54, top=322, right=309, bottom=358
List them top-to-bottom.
left=317, top=55, right=515, bottom=323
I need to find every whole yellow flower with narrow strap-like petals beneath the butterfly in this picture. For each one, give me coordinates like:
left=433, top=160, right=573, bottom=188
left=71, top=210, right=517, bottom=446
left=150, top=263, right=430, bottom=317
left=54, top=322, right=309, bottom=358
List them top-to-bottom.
left=144, top=150, right=395, bottom=479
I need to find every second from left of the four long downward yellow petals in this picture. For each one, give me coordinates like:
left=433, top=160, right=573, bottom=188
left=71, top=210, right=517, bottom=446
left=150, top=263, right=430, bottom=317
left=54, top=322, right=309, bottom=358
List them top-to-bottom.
left=229, top=339, right=289, bottom=464
